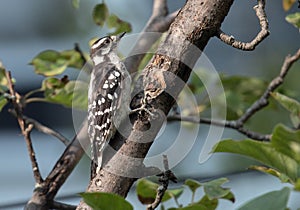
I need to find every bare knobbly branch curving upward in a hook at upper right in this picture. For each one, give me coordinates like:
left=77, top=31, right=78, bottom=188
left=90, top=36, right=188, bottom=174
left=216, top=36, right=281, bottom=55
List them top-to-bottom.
left=217, top=0, right=270, bottom=51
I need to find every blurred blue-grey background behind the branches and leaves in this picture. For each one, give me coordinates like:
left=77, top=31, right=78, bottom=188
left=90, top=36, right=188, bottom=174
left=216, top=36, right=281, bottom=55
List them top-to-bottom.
left=0, top=0, right=300, bottom=210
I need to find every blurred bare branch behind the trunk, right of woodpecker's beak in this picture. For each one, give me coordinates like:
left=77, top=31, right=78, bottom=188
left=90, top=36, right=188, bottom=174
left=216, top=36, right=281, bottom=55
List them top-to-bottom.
left=124, top=0, right=178, bottom=73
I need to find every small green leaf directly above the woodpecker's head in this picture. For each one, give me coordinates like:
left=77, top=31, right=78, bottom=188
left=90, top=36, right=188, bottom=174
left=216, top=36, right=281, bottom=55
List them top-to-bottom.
left=107, top=14, right=132, bottom=35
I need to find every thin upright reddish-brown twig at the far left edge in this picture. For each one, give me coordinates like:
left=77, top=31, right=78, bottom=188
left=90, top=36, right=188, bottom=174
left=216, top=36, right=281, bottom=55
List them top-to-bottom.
left=5, top=71, right=43, bottom=184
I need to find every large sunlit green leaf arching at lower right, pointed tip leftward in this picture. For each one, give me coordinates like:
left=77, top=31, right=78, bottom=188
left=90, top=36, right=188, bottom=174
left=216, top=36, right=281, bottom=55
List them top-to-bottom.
left=213, top=139, right=299, bottom=181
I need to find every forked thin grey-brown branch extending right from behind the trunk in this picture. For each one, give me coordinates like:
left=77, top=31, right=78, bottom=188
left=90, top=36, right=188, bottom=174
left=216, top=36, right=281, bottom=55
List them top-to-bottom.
left=168, top=49, right=300, bottom=141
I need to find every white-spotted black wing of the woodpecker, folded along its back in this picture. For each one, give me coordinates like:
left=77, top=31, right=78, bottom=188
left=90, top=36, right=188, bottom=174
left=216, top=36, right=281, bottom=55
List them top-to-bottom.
left=88, top=65, right=122, bottom=176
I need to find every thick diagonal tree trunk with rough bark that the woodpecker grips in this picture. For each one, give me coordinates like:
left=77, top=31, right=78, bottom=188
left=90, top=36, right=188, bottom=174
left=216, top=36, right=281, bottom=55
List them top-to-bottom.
left=78, top=0, right=233, bottom=209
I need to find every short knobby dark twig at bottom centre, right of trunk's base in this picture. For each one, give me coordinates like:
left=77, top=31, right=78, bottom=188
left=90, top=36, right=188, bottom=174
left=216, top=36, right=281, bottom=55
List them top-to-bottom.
left=147, top=155, right=177, bottom=210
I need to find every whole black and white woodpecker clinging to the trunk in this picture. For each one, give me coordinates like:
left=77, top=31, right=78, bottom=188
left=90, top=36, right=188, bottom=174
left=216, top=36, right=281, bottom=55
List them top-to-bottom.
left=88, top=33, right=131, bottom=178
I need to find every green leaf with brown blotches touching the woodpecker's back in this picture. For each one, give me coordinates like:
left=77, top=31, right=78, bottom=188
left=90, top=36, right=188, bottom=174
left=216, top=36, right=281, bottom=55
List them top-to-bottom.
left=42, top=77, right=88, bottom=110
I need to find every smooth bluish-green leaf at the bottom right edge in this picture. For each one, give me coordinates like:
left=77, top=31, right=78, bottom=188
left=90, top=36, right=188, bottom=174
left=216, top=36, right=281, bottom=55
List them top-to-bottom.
left=238, top=187, right=290, bottom=210
